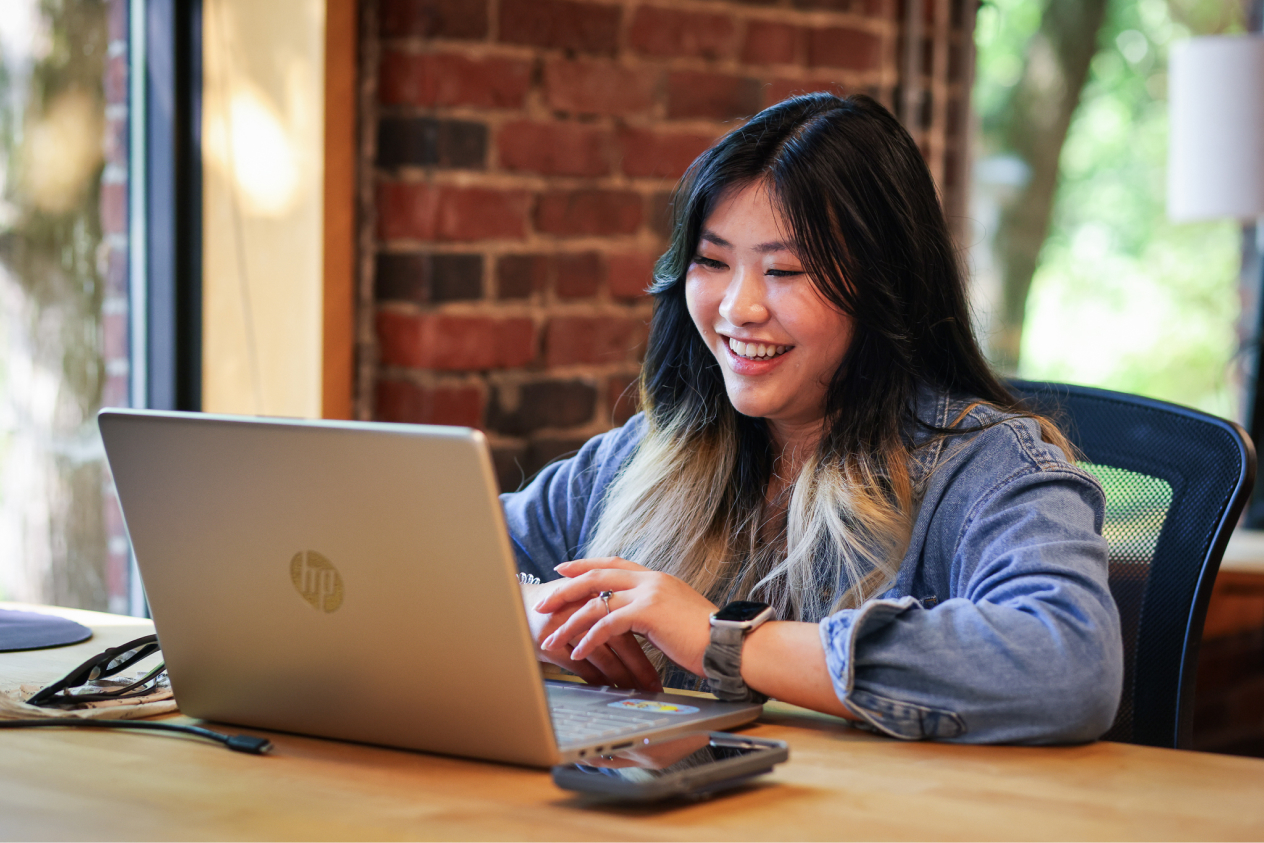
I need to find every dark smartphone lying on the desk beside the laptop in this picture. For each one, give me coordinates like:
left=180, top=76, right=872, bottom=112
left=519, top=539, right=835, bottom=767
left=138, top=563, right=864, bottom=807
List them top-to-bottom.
left=554, top=732, right=790, bottom=801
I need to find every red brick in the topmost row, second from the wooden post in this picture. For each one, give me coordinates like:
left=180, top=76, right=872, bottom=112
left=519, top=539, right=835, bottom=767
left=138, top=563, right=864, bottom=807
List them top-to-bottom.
left=500, top=0, right=623, bottom=56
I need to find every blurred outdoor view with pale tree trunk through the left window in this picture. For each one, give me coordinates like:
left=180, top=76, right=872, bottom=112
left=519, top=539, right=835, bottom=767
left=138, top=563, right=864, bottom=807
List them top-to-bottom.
left=0, top=0, right=118, bottom=610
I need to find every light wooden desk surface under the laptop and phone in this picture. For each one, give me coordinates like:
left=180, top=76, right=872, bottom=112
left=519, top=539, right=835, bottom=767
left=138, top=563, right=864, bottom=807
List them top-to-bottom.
left=0, top=607, right=1264, bottom=840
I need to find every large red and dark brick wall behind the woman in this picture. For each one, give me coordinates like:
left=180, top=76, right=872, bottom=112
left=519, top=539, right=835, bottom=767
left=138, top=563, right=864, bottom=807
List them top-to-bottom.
left=356, top=0, right=973, bottom=488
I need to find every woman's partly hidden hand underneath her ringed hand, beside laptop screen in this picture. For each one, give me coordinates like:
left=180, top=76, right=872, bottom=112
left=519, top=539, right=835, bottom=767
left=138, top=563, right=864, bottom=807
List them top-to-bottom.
left=522, top=579, right=662, bottom=693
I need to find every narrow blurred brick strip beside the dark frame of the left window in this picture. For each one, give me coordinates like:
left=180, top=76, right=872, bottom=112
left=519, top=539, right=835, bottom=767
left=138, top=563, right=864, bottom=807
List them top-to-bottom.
left=101, top=0, right=131, bottom=613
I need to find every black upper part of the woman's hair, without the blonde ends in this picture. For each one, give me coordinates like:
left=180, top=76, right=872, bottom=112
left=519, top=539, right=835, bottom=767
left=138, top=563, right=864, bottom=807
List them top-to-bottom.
left=643, top=94, right=1016, bottom=465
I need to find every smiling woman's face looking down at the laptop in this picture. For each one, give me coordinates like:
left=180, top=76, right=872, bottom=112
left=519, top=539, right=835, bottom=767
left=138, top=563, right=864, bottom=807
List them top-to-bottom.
left=685, top=182, right=852, bottom=441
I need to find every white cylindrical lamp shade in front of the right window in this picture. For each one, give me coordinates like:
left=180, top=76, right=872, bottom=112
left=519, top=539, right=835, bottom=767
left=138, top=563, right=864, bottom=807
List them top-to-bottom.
left=1168, top=34, right=1264, bottom=222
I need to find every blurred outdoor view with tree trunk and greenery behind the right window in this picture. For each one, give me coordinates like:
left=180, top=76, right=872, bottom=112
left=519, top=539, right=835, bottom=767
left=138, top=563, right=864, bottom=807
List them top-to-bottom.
left=969, top=0, right=1250, bottom=421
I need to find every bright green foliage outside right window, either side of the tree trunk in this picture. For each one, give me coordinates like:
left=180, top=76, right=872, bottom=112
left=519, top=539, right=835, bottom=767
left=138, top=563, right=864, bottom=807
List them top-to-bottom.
left=973, top=0, right=1241, bottom=416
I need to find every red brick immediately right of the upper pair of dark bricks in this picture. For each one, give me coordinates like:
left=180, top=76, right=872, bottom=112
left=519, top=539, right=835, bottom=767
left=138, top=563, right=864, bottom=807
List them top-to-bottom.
left=499, top=120, right=611, bottom=176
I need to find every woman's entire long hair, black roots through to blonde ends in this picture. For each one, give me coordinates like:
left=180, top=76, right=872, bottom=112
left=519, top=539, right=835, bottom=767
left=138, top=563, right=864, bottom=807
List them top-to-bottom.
left=588, top=94, right=1051, bottom=619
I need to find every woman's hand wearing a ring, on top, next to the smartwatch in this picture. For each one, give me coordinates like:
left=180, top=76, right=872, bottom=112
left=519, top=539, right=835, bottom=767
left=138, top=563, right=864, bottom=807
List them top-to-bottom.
left=532, top=556, right=715, bottom=676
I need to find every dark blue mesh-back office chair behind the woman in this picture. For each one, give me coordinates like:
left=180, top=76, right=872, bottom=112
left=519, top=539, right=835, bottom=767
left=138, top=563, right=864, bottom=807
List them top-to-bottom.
left=1010, top=380, right=1255, bottom=748
